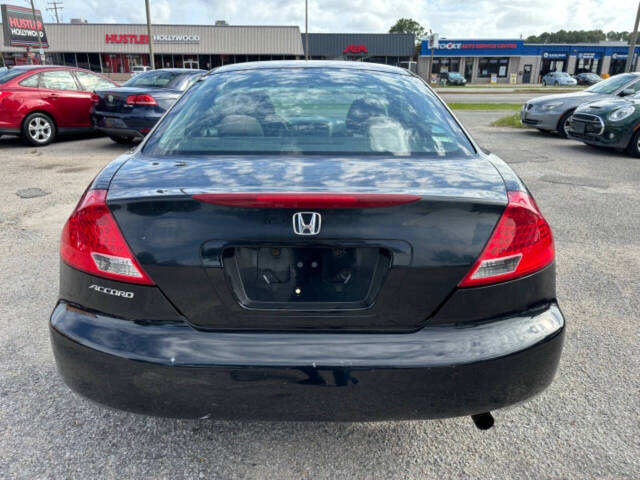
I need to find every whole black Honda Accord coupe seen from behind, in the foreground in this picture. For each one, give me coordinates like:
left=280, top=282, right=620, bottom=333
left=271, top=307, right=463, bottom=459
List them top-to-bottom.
left=50, top=61, right=564, bottom=428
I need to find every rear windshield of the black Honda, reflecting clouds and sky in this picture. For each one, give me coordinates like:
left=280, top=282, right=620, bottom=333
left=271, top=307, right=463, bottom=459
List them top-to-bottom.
left=144, top=68, right=474, bottom=157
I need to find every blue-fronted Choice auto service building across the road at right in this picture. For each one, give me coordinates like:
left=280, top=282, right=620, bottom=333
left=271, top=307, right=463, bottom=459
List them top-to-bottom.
left=418, top=39, right=640, bottom=83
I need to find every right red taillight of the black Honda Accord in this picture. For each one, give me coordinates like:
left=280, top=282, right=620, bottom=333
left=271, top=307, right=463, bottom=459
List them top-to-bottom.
left=459, top=192, right=555, bottom=287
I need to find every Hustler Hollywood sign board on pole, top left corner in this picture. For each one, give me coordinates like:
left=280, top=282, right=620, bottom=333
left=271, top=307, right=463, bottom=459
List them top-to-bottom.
left=2, top=5, right=49, bottom=48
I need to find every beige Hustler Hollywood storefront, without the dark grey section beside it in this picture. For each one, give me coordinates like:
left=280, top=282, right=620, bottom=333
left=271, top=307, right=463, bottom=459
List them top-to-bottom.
left=0, top=23, right=304, bottom=78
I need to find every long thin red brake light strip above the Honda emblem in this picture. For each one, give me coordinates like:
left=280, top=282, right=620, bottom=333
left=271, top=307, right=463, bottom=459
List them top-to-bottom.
left=193, top=193, right=421, bottom=208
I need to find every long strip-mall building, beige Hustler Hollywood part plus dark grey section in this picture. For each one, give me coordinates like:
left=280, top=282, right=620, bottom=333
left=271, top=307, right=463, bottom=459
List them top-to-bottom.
left=0, top=21, right=415, bottom=79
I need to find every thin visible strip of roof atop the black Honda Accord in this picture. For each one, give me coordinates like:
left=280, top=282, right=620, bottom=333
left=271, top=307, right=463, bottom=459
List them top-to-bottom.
left=212, top=60, right=412, bottom=75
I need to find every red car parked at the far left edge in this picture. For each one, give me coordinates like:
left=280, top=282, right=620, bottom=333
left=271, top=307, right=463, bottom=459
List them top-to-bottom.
left=0, top=65, right=118, bottom=146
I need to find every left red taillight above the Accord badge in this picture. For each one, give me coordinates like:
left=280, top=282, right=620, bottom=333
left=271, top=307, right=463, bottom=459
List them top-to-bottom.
left=60, top=190, right=153, bottom=285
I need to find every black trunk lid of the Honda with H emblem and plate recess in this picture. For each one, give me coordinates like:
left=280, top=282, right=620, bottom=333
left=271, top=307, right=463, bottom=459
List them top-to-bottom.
left=108, top=155, right=507, bottom=331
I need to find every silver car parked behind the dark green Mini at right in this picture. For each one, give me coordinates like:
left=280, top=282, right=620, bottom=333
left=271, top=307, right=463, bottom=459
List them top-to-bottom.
left=520, top=72, right=640, bottom=138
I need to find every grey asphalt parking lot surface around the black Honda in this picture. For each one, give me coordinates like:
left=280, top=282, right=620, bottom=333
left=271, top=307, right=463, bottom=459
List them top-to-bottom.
left=0, top=107, right=640, bottom=479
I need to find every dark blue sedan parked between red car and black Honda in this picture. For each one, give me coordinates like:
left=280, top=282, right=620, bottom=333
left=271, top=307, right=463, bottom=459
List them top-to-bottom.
left=91, top=68, right=206, bottom=143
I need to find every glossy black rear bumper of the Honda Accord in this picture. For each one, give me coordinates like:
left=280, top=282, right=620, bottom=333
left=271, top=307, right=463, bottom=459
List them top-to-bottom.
left=50, top=302, right=564, bottom=421
